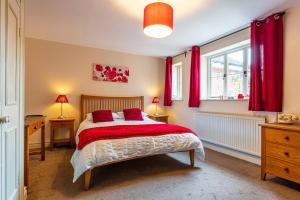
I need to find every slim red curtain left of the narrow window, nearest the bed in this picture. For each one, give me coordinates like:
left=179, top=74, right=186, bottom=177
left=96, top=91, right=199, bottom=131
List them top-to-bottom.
left=164, top=57, right=172, bottom=106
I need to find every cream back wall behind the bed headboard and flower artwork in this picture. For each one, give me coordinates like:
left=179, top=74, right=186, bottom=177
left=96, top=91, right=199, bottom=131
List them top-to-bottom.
left=25, top=38, right=164, bottom=144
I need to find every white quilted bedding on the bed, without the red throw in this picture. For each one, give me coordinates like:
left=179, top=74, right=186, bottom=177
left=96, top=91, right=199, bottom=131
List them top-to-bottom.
left=71, top=117, right=204, bottom=182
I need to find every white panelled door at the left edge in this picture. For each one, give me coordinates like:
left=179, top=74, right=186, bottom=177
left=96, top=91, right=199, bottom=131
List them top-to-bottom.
left=0, top=0, right=23, bottom=200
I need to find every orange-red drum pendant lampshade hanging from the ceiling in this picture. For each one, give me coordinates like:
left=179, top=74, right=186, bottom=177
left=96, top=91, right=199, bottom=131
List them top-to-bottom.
left=144, top=2, right=173, bottom=38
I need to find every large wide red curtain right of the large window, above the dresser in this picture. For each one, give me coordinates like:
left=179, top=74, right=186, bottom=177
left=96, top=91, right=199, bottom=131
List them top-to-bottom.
left=249, top=13, right=283, bottom=112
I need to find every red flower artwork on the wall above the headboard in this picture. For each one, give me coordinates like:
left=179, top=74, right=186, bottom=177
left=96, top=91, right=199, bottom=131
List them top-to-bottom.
left=93, top=64, right=129, bottom=83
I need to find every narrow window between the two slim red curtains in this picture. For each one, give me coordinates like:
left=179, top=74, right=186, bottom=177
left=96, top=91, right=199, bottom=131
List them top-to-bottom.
left=172, top=62, right=182, bottom=100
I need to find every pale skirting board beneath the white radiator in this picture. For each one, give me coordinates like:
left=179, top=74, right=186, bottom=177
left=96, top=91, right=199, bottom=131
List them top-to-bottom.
left=202, top=140, right=261, bottom=165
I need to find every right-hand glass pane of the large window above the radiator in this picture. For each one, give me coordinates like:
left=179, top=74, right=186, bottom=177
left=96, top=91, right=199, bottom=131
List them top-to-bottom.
left=227, top=50, right=244, bottom=98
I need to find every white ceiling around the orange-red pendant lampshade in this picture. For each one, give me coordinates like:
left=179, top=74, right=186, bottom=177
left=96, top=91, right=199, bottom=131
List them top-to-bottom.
left=25, top=0, right=300, bottom=57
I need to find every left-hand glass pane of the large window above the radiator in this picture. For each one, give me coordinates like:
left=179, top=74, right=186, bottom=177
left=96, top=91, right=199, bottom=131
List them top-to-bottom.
left=210, top=56, right=225, bottom=97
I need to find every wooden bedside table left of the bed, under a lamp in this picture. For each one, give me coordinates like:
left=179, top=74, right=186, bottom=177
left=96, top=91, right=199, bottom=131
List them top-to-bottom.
left=49, top=118, right=75, bottom=150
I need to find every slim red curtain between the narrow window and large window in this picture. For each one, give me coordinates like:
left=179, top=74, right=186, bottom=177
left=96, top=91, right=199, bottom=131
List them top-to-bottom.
left=189, top=46, right=200, bottom=107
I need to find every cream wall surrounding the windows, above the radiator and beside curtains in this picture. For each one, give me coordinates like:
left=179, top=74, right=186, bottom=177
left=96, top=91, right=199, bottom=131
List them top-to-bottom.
left=167, top=7, right=300, bottom=128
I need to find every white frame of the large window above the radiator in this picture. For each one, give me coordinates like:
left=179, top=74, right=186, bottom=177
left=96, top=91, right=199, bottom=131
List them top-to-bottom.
left=207, top=44, right=251, bottom=100
